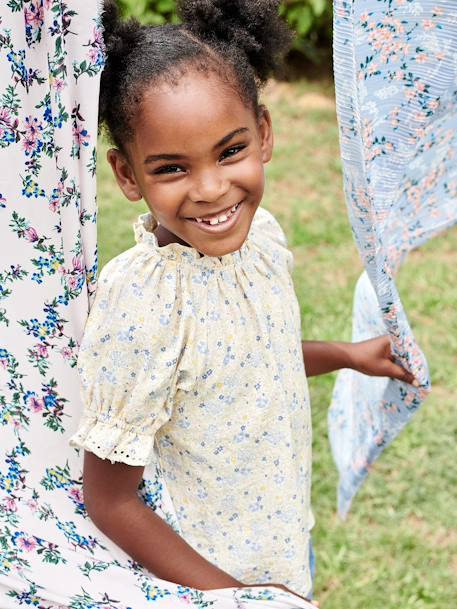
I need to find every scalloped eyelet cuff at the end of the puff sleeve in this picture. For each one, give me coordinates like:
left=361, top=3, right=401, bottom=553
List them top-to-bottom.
left=70, top=417, right=154, bottom=466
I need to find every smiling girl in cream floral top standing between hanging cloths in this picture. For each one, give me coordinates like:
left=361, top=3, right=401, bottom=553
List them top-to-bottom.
left=73, top=0, right=413, bottom=597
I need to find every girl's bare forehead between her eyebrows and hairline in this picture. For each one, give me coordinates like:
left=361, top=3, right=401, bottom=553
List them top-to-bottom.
left=134, top=73, right=256, bottom=152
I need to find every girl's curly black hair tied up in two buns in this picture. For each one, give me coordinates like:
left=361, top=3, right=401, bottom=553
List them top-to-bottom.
left=99, top=0, right=291, bottom=150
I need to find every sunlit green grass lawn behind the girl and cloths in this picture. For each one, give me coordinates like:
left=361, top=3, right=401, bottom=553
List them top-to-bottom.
left=99, top=82, right=457, bottom=609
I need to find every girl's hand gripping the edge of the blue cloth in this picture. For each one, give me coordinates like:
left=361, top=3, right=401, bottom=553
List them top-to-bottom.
left=349, top=336, right=419, bottom=387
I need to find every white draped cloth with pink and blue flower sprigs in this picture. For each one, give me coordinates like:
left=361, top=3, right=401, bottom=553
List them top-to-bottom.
left=0, top=0, right=310, bottom=609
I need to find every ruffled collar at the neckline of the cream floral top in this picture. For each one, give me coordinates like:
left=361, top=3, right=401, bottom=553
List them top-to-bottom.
left=134, top=213, right=252, bottom=268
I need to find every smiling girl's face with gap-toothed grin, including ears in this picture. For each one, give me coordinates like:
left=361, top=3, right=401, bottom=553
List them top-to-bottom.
left=108, top=73, right=273, bottom=256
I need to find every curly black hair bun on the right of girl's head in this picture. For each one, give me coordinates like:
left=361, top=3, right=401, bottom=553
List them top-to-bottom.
left=178, top=0, right=291, bottom=82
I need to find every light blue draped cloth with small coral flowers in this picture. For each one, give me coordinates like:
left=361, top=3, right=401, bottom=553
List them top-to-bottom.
left=329, top=0, right=457, bottom=516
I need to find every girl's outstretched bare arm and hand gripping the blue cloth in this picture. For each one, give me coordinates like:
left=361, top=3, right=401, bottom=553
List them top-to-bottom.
left=302, top=336, right=417, bottom=386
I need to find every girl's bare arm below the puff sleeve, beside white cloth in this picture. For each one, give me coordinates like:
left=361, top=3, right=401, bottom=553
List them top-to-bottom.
left=84, top=452, right=241, bottom=590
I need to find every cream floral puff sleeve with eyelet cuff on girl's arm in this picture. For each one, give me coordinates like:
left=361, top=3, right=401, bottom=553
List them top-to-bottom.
left=71, top=248, right=182, bottom=466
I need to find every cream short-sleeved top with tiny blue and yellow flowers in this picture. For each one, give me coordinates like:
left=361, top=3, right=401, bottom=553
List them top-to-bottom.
left=72, top=209, right=312, bottom=594
